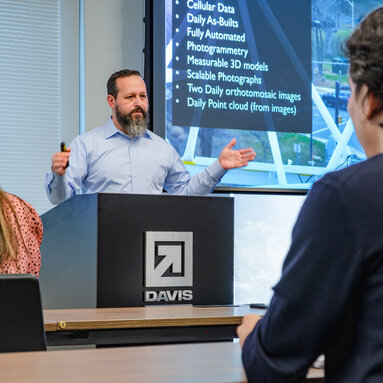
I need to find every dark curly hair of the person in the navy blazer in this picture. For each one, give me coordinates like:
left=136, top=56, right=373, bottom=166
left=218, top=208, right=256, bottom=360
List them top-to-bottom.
left=344, top=7, right=383, bottom=118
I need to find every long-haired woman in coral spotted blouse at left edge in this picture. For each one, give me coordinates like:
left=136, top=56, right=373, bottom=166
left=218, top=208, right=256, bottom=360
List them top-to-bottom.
left=0, top=189, right=43, bottom=277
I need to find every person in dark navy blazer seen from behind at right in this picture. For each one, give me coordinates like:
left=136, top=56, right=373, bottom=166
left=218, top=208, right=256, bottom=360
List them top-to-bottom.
left=237, top=7, right=383, bottom=383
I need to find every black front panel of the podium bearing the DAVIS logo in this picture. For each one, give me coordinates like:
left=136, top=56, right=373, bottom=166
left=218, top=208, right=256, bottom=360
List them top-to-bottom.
left=97, top=194, right=234, bottom=307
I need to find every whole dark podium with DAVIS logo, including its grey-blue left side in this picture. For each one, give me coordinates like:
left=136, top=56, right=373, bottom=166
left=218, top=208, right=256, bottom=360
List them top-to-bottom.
left=40, top=193, right=234, bottom=309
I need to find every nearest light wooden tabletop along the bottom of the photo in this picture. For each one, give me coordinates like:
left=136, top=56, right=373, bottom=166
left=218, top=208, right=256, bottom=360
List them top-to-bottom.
left=0, top=342, right=323, bottom=383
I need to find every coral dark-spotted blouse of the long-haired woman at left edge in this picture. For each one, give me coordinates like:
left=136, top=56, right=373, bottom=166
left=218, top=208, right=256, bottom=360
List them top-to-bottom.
left=0, top=193, right=43, bottom=277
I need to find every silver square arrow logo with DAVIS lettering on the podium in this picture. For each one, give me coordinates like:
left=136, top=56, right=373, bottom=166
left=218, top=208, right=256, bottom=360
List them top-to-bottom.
left=145, top=231, right=193, bottom=302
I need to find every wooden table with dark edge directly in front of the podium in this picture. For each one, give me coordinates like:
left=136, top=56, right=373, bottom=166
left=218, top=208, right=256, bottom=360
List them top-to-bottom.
left=44, top=305, right=265, bottom=346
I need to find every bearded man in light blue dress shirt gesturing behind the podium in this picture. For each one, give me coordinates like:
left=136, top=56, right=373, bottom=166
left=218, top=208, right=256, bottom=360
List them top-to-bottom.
left=45, top=69, right=255, bottom=204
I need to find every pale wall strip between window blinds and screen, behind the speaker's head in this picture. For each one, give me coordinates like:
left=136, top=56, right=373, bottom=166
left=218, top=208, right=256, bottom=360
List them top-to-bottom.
left=85, top=0, right=145, bottom=130
